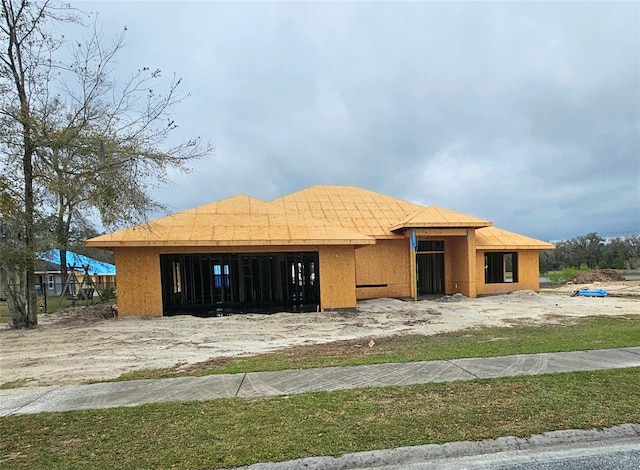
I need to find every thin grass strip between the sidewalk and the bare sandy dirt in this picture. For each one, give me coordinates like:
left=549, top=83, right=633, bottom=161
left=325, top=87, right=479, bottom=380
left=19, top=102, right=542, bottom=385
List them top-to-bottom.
left=118, top=315, right=640, bottom=380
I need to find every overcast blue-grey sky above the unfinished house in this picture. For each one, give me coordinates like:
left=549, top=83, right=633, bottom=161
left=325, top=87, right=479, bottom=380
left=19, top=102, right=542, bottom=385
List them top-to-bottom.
left=73, top=1, right=640, bottom=240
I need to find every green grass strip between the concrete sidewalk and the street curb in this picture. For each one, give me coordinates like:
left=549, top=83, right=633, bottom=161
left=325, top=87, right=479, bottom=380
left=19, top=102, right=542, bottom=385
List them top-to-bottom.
left=0, top=368, right=640, bottom=469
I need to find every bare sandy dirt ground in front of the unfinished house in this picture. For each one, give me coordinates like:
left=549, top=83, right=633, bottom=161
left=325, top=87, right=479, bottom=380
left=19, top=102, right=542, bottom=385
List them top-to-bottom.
left=0, top=281, right=640, bottom=386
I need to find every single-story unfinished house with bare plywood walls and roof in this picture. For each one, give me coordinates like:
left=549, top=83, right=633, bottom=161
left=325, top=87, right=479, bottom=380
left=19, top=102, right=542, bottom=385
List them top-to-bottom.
left=85, top=186, right=554, bottom=316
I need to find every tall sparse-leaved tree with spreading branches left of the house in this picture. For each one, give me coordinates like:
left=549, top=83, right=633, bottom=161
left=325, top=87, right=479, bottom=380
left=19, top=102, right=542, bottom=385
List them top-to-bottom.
left=0, top=0, right=212, bottom=327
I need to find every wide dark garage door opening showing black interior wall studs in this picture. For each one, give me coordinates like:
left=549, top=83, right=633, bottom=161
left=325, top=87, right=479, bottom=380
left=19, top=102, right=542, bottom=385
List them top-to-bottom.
left=160, top=252, right=320, bottom=316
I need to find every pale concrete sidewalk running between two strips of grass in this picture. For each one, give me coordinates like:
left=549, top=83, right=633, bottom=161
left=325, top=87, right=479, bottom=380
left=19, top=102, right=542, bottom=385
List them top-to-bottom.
left=0, top=347, right=640, bottom=416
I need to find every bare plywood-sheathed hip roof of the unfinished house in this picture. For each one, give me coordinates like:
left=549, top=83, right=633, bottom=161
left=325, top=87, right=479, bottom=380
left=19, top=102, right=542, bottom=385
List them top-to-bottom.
left=85, top=186, right=553, bottom=250
